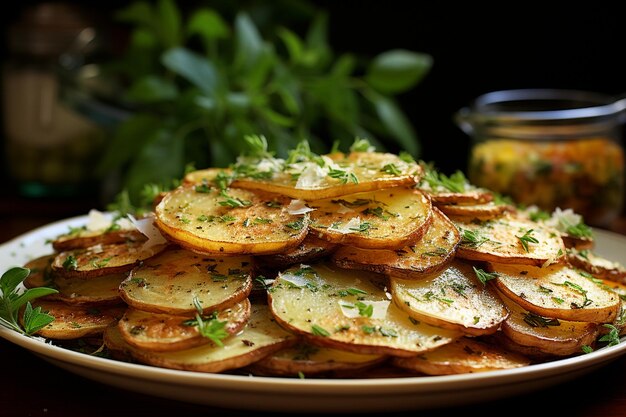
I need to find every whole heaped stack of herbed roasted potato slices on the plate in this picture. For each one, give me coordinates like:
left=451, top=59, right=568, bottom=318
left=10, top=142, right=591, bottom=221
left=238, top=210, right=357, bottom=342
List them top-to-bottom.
left=26, top=136, right=626, bottom=378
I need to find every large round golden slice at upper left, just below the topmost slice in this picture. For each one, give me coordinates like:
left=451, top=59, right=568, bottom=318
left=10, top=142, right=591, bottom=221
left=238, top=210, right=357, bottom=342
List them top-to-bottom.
left=156, top=186, right=308, bottom=255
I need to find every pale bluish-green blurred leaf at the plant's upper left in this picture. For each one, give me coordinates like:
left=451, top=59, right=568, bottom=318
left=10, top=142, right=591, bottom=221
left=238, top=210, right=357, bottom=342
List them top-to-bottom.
left=161, top=47, right=218, bottom=96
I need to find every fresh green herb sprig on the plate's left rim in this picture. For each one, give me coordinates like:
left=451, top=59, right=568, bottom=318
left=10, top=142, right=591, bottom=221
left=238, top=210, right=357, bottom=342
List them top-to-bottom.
left=0, top=267, right=58, bottom=335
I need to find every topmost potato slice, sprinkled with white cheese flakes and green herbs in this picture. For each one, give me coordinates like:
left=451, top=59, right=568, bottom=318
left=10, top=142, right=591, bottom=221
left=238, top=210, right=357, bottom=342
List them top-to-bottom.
left=232, top=152, right=422, bottom=200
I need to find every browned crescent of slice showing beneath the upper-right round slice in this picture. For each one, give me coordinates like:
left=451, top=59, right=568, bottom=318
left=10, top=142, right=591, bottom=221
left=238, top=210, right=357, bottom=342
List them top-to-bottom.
left=331, top=207, right=461, bottom=279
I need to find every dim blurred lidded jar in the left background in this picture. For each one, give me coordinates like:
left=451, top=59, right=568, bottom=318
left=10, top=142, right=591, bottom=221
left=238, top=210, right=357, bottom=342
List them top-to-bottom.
left=2, top=2, right=105, bottom=197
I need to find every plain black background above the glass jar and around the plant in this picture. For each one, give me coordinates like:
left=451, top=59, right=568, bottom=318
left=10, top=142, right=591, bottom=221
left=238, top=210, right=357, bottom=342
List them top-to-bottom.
left=0, top=0, right=626, bottom=193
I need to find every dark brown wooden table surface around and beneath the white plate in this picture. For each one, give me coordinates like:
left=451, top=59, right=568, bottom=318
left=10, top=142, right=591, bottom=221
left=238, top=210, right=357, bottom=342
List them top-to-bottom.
left=0, top=196, right=626, bottom=417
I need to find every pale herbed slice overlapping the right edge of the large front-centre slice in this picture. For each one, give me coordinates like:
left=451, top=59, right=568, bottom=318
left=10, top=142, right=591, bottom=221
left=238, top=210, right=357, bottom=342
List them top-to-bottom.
left=390, top=260, right=508, bottom=336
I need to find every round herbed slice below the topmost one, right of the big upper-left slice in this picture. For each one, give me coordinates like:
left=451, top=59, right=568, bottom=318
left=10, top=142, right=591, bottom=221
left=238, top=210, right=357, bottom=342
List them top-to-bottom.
left=309, top=187, right=432, bottom=249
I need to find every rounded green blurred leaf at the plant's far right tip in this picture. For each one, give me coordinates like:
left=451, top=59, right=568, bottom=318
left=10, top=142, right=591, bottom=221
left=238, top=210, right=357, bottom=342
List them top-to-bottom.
left=365, top=49, right=433, bottom=94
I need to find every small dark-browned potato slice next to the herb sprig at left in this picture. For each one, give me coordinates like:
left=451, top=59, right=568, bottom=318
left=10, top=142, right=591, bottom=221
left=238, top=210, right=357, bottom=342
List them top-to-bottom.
left=32, top=299, right=126, bottom=339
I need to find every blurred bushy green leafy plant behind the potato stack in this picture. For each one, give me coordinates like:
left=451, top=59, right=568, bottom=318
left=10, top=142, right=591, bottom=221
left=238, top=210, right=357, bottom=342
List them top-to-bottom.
left=98, top=0, right=432, bottom=204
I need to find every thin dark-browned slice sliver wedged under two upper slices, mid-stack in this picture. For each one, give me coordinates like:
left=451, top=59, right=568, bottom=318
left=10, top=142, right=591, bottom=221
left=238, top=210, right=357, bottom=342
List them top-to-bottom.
left=256, top=233, right=338, bottom=268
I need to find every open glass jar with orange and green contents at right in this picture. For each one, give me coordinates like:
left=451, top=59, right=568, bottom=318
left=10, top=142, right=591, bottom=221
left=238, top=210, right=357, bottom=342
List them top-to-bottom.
left=455, top=89, right=626, bottom=227
